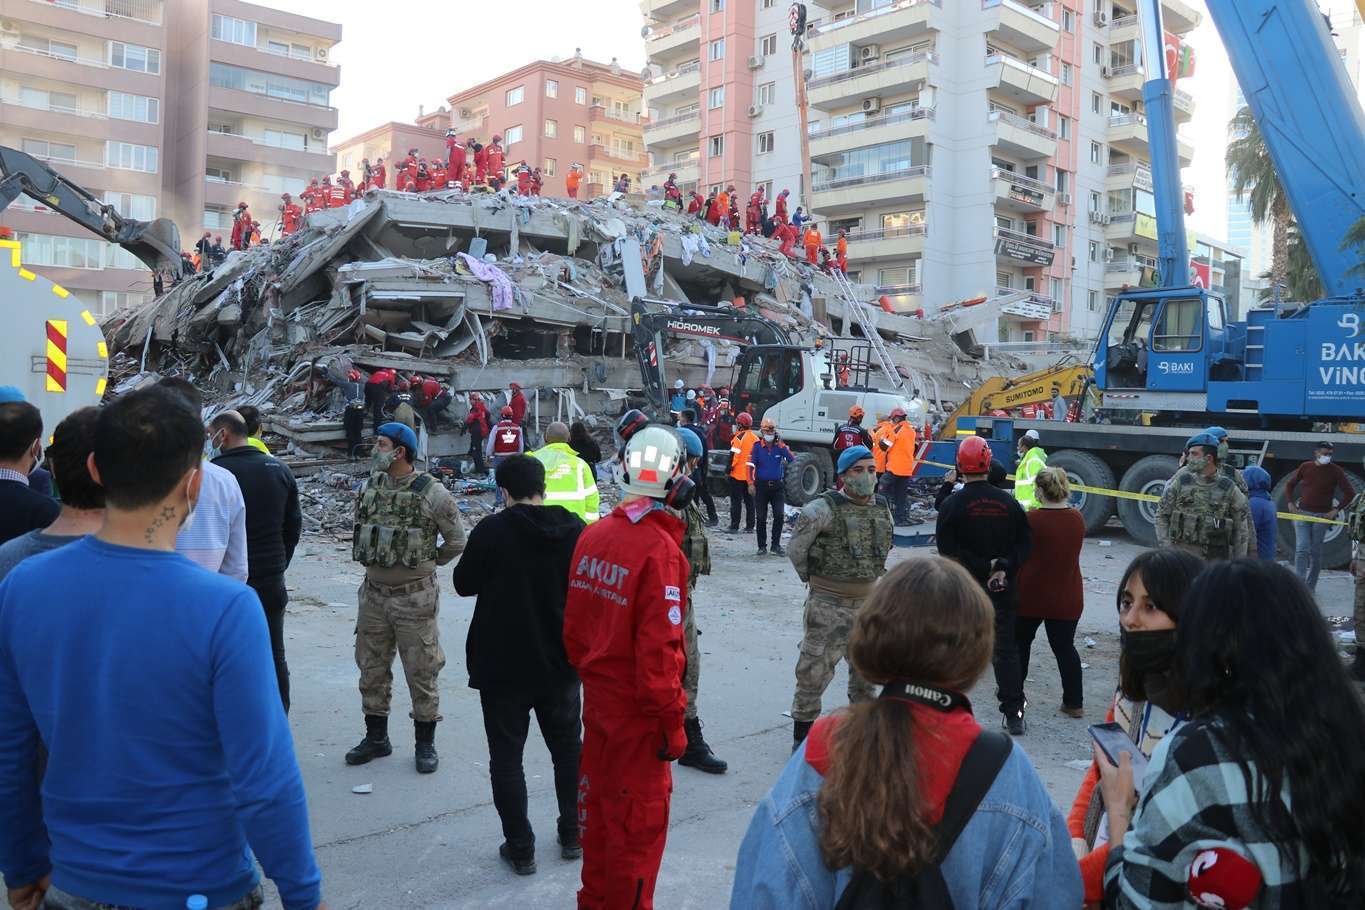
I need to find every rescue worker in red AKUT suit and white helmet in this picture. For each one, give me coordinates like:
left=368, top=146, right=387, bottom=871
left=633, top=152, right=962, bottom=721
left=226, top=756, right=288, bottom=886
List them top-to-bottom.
left=564, top=424, right=692, bottom=910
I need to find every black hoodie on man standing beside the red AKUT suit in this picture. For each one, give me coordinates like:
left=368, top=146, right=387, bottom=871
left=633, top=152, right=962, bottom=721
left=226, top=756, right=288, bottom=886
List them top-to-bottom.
left=455, top=505, right=586, bottom=696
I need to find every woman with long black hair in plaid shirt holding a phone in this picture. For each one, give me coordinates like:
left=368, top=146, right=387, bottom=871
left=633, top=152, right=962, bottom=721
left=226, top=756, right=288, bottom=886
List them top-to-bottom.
left=1096, top=559, right=1365, bottom=910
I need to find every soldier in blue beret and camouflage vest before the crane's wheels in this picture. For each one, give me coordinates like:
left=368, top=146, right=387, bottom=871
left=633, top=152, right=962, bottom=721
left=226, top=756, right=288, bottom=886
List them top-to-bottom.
left=1152, top=430, right=1250, bottom=559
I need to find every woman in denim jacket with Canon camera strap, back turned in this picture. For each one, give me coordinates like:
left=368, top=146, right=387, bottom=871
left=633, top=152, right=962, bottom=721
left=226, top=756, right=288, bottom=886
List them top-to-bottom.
left=730, top=557, right=1081, bottom=910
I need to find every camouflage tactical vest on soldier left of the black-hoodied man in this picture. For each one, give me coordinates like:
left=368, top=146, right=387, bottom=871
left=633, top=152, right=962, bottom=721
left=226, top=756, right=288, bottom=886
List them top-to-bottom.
left=351, top=473, right=437, bottom=569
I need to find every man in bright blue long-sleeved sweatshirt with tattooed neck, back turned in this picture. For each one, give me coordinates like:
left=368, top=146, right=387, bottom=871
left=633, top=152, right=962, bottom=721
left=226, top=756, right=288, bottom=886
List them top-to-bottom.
left=0, top=386, right=324, bottom=910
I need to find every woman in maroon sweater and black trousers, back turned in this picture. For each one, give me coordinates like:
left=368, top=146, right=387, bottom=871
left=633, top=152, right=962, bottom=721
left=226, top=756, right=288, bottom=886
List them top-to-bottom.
left=1014, top=468, right=1085, bottom=718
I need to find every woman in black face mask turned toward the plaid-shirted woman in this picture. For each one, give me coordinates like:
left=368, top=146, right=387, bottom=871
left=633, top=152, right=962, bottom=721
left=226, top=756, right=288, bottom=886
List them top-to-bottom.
left=1067, top=548, right=1204, bottom=907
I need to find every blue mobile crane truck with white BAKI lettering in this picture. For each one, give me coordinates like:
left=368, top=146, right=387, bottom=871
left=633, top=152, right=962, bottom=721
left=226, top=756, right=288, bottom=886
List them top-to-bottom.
left=976, top=0, right=1365, bottom=568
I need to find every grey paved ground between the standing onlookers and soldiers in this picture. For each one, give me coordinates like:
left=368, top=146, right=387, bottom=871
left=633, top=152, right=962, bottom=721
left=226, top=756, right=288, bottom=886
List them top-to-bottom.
left=8, top=503, right=1350, bottom=910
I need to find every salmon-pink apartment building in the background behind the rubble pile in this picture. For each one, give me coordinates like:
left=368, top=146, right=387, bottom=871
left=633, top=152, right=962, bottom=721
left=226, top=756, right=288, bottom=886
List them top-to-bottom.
left=416, top=52, right=646, bottom=198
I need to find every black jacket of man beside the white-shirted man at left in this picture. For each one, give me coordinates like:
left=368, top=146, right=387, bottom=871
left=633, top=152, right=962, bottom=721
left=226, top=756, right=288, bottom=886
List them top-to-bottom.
left=213, top=446, right=303, bottom=580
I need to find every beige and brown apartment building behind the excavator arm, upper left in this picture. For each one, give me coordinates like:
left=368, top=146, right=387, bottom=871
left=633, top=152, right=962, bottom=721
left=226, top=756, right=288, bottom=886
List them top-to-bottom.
left=0, top=0, right=341, bottom=312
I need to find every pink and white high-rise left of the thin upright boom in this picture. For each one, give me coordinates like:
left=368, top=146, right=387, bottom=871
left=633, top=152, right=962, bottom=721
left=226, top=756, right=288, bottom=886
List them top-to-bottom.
left=640, top=0, right=824, bottom=210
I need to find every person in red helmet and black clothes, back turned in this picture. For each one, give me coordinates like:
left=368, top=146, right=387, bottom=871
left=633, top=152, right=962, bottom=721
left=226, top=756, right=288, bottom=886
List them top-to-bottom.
left=934, top=437, right=1033, bottom=737
